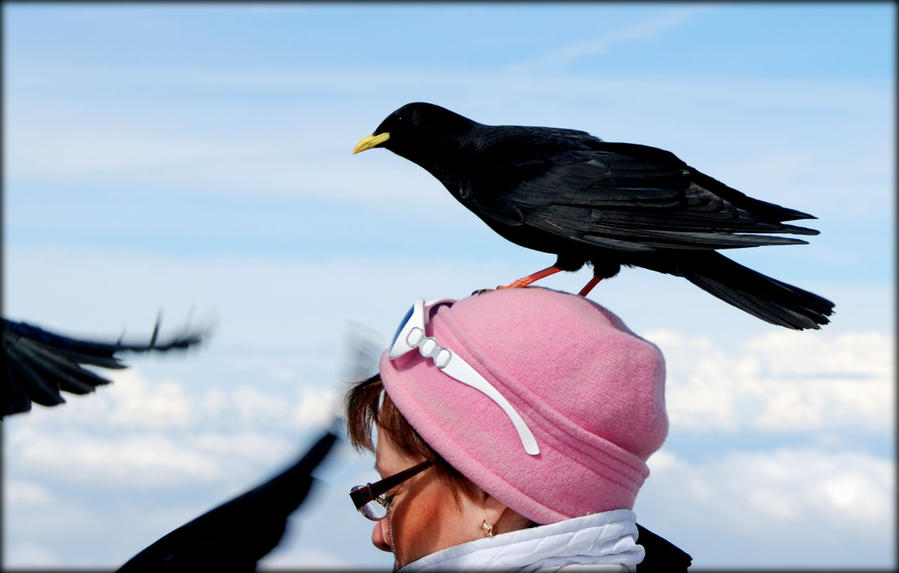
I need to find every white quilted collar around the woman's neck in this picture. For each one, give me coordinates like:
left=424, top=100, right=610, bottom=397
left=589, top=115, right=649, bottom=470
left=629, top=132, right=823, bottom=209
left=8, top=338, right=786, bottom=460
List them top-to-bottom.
left=400, top=509, right=645, bottom=573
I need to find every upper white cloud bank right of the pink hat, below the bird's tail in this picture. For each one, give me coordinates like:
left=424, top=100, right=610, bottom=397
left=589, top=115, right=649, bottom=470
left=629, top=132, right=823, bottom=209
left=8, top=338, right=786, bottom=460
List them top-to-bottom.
left=644, top=331, right=895, bottom=432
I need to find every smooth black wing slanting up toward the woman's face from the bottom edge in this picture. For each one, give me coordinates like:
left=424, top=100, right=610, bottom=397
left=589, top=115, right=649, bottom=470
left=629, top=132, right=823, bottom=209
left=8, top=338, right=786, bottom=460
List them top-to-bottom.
left=119, top=431, right=337, bottom=573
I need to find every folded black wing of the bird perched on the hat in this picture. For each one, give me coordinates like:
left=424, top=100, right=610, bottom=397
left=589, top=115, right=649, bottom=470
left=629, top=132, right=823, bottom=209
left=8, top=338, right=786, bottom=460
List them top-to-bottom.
left=486, top=140, right=817, bottom=251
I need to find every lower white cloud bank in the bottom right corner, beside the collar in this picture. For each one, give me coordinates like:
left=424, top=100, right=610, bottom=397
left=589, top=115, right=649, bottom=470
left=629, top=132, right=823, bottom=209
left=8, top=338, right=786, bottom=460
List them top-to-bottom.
left=636, top=448, right=896, bottom=567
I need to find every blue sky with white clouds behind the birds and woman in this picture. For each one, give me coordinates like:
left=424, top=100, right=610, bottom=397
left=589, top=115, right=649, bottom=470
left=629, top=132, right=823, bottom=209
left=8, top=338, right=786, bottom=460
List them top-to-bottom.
left=3, top=3, right=895, bottom=567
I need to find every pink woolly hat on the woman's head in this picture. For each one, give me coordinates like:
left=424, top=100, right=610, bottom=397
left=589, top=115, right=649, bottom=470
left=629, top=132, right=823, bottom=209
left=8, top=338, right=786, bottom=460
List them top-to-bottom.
left=381, top=287, right=668, bottom=524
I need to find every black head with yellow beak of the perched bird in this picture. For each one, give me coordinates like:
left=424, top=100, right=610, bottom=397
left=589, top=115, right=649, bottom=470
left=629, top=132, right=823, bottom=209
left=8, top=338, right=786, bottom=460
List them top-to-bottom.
left=353, top=102, right=474, bottom=163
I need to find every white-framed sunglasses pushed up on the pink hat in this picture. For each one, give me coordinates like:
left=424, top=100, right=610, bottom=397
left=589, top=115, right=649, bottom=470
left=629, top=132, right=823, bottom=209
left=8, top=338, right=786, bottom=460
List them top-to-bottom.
left=387, top=298, right=540, bottom=456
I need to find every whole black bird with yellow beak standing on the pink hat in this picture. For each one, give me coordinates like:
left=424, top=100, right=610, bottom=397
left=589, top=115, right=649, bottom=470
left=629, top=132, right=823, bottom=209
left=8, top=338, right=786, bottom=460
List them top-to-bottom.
left=353, top=103, right=834, bottom=330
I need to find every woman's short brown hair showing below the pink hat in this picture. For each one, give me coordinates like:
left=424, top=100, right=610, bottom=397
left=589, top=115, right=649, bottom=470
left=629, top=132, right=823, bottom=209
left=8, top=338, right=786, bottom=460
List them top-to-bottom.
left=346, top=374, right=478, bottom=502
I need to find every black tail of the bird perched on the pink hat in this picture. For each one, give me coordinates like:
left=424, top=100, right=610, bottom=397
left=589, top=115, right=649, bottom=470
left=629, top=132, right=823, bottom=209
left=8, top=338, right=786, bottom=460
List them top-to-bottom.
left=647, top=252, right=834, bottom=330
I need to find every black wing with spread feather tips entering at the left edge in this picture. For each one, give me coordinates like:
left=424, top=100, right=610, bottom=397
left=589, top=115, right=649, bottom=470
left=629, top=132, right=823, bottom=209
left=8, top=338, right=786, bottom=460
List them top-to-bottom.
left=0, top=318, right=202, bottom=419
